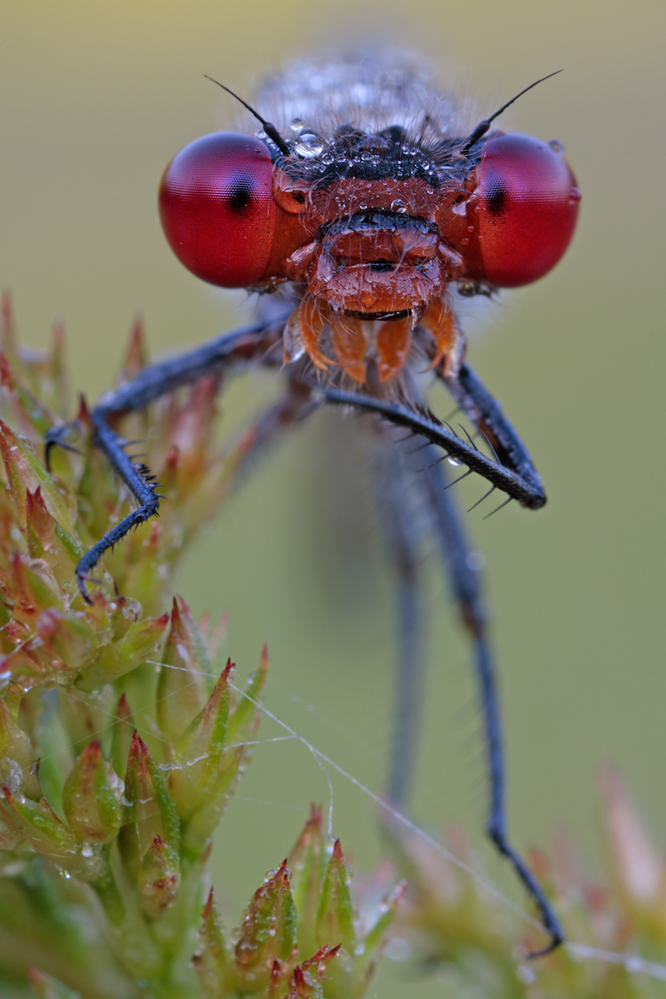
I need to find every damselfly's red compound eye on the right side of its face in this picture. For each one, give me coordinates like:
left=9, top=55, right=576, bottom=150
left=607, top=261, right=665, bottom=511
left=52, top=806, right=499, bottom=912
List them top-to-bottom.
left=477, top=133, right=580, bottom=288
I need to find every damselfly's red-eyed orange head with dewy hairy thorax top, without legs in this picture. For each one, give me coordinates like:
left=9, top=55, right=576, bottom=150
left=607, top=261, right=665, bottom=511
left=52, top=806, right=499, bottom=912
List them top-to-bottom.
left=159, top=51, right=580, bottom=388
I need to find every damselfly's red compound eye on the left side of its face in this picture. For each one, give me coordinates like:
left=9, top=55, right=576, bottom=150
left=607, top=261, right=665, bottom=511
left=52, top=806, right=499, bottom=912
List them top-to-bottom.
left=159, top=132, right=275, bottom=288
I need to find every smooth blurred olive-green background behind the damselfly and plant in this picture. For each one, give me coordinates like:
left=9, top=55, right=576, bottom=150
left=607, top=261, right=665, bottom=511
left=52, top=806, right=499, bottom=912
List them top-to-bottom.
left=0, top=0, right=666, bottom=997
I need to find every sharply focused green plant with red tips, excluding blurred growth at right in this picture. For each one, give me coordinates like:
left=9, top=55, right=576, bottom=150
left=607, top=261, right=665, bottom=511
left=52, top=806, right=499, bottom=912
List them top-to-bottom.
left=0, top=301, right=398, bottom=999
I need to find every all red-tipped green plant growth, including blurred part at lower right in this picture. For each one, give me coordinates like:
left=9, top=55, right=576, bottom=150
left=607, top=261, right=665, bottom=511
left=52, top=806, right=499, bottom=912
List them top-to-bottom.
left=0, top=298, right=666, bottom=999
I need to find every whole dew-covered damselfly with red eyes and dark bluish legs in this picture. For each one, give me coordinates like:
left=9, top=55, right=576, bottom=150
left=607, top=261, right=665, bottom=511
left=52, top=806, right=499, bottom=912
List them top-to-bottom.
left=47, top=52, right=580, bottom=953
